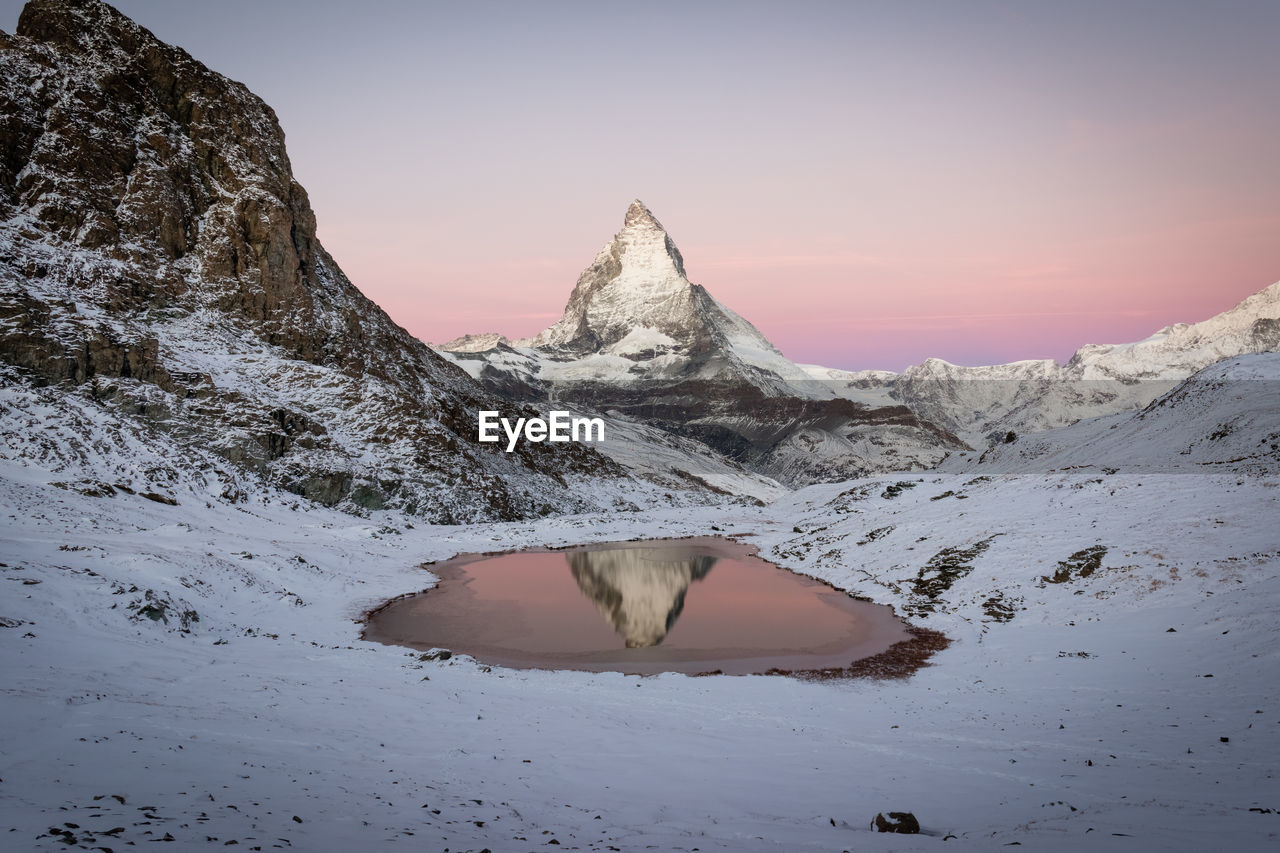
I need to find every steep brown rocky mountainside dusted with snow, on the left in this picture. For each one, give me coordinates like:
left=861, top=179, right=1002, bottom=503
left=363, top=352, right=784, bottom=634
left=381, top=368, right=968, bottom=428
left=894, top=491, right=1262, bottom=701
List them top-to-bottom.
left=0, top=0, right=777, bottom=521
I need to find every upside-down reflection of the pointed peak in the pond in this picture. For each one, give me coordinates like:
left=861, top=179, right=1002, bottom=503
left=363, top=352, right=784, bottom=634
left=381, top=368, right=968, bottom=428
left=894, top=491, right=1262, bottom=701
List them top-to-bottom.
left=564, top=548, right=716, bottom=648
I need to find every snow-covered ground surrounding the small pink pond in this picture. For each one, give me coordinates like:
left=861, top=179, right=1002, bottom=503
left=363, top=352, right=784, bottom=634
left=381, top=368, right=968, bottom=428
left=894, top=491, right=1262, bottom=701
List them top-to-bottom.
left=0, top=348, right=1280, bottom=852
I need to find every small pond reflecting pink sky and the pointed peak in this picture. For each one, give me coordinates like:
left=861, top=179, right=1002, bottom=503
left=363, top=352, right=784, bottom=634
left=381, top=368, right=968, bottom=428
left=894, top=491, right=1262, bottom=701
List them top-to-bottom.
left=365, top=537, right=909, bottom=675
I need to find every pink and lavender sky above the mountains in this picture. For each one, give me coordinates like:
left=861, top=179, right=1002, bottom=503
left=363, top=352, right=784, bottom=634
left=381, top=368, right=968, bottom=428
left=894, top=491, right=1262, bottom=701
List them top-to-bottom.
left=0, top=0, right=1280, bottom=369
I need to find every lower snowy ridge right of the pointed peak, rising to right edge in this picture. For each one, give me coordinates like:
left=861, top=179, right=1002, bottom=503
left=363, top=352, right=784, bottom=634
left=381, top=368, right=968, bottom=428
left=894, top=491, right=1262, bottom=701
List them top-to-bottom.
left=806, top=282, right=1280, bottom=447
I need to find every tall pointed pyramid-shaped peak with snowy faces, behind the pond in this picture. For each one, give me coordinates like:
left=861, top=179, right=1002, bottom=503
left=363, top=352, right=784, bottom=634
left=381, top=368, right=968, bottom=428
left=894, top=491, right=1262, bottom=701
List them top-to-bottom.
left=439, top=201, right=963, bottom=485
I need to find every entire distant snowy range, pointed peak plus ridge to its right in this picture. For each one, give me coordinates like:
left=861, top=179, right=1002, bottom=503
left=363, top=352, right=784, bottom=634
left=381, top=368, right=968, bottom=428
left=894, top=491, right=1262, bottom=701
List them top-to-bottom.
left=436, top=201, right=1280, bottom=485
